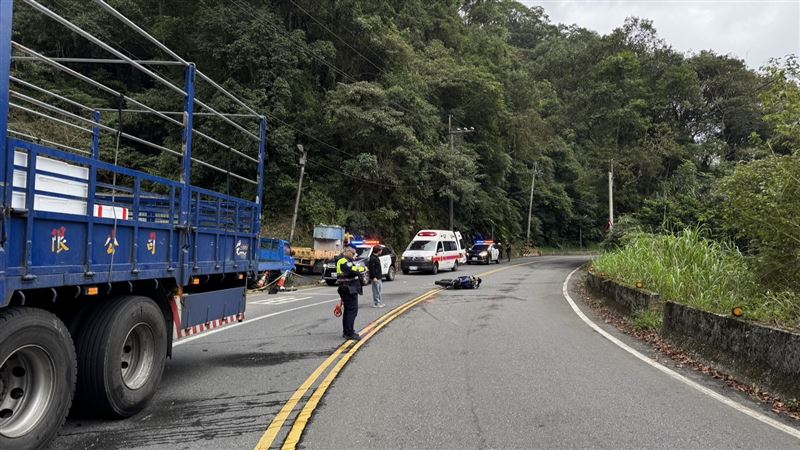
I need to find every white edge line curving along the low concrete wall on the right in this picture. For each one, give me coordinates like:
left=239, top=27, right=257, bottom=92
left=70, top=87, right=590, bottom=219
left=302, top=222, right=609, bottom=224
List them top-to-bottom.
left=562, top=267, right=800, bottom=439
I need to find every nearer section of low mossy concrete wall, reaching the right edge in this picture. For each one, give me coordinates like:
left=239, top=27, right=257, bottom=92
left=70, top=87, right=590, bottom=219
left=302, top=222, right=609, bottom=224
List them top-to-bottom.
left=663, top=302, right=800, bottom=399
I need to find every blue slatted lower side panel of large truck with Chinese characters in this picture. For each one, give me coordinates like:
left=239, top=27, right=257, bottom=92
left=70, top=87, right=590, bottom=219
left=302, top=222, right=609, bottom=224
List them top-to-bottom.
left=3, top=138, right=259, bottom=305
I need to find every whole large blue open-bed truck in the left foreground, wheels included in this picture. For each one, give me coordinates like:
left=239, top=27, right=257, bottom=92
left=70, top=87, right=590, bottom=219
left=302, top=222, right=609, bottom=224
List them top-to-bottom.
left=0, top=0, right=267, bottom=449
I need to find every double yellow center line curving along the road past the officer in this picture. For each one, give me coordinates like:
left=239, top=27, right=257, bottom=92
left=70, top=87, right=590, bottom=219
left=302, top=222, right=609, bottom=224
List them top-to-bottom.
left=255, top=289, right=441, bottom=450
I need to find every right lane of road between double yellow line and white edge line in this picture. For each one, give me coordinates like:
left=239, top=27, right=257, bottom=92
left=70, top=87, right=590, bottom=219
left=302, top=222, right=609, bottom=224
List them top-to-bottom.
left=300, top=257, right=800, bottom=449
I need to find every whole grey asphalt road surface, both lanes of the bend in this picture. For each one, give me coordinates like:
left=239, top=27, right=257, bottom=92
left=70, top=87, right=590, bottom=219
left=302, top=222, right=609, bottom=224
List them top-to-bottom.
left=52, top=257, right=800, bottom=449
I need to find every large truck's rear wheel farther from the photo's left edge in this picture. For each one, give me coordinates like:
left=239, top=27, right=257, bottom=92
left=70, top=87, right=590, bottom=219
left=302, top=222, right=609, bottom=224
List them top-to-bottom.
left=77, top=295, right=167, bottom=417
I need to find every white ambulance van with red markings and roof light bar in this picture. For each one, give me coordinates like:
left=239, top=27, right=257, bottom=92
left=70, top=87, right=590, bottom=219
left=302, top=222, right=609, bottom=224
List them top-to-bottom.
left=400, top=230, right=467, bottom=274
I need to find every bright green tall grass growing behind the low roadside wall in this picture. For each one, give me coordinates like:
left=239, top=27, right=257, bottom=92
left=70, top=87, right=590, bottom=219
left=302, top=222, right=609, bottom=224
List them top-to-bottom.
left=592, top=229, right=800, bottom=328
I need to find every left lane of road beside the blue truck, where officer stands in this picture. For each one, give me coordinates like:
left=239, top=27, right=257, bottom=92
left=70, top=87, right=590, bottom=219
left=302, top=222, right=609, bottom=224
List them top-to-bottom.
left=50, top=258, right=494, bottom=450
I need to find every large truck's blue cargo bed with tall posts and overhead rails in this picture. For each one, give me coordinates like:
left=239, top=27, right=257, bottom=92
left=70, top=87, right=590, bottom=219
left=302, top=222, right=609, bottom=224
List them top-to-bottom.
left=0, top=0, right=267, bottom=306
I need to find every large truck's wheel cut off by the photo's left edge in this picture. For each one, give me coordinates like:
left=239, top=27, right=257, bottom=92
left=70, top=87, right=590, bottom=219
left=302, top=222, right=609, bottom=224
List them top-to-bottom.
left=0, top=307, right=77, bottom=449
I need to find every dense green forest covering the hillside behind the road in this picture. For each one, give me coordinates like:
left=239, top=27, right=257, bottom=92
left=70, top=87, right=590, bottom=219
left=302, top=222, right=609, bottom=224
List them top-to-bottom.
left=7, top=0, right=800, bottom=261
